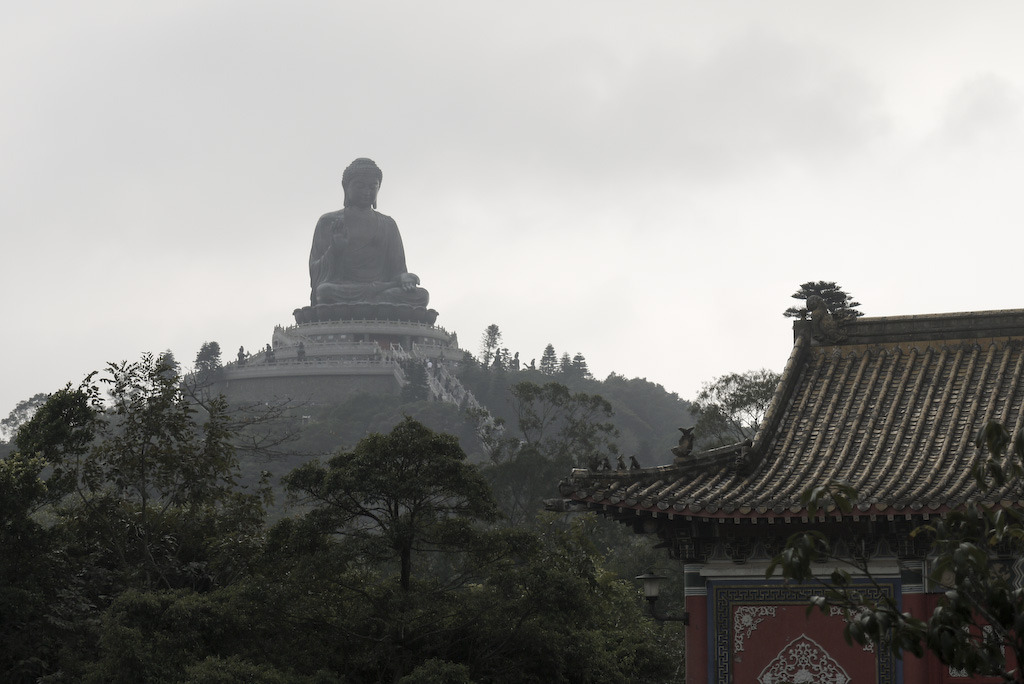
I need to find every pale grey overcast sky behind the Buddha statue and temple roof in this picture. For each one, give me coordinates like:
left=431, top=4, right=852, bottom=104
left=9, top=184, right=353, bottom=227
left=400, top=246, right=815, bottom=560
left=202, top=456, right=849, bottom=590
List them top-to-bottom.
left=0, top=0, right=1024, bottom=416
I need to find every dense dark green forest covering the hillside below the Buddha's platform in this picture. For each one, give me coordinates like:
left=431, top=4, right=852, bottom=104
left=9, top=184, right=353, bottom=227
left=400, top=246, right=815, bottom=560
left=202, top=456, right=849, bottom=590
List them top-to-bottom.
left=0, top=329, right=712, bottom=684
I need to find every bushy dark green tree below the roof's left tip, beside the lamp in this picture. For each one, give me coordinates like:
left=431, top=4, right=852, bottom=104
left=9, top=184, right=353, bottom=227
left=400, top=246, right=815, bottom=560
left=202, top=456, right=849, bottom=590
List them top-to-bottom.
left=447, top=514, right=682, bottom=684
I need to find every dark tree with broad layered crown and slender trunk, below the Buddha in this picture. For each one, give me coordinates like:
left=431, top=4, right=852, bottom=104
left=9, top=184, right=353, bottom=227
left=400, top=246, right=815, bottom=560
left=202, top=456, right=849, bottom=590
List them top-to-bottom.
left=286, top=419, right=505, bottom=682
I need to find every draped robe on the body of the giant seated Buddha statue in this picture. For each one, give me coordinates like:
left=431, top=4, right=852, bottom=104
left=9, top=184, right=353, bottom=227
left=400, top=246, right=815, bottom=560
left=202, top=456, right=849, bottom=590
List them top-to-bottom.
left=309, top=209, right=430, bottom=306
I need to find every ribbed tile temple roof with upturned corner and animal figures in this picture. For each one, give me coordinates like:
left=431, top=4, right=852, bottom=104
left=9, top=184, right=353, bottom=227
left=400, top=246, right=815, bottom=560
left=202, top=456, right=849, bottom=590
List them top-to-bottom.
left=560, top=309, right=1024, bottom=519
